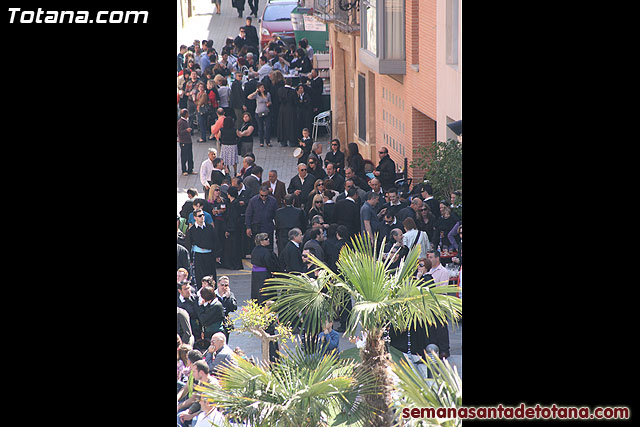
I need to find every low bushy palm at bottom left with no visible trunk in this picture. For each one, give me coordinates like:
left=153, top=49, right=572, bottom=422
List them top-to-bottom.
left=196, top=347, right=372, bottom=427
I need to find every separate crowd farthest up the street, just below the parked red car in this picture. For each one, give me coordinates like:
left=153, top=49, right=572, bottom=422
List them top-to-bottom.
left=177, top=21, right=324, bottom=175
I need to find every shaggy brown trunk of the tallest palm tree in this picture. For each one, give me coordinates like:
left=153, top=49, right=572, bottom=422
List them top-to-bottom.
left=360, top=329, right=393, bottom=427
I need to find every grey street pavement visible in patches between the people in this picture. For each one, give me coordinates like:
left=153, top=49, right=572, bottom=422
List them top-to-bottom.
left=176, top=0, right=462, bottom=376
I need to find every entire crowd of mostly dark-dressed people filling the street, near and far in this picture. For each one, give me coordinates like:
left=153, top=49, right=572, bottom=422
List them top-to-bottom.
left=177, top=26, right=462, bottom=426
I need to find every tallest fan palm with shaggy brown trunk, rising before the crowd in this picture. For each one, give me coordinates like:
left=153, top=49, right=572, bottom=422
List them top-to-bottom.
left=266, top=235, right=462, bottom=427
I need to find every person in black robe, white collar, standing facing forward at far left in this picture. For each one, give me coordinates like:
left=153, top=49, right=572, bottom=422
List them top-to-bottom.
left=186, top=209, right=222, bottom=288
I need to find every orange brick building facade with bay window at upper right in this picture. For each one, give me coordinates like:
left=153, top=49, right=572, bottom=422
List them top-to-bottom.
left=316, top=0, right=462, bottom=181
